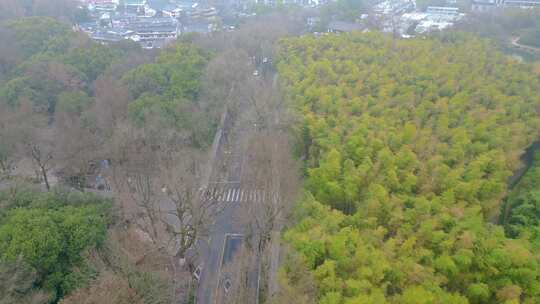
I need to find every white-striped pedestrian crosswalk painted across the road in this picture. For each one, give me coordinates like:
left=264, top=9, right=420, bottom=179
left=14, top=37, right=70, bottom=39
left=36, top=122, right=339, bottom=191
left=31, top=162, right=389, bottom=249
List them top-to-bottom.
left=200, top=188, right=269, bottom=203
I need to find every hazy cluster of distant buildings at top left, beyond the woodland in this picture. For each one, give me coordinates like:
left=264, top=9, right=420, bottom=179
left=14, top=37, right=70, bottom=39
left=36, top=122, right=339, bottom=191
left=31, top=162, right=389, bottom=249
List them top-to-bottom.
left=76, top=0, right=334, bottom=49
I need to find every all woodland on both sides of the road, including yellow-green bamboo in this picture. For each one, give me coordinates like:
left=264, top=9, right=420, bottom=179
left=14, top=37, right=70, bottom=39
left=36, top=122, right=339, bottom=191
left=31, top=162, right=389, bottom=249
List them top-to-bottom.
left=0, top=0, right=540, bottom=304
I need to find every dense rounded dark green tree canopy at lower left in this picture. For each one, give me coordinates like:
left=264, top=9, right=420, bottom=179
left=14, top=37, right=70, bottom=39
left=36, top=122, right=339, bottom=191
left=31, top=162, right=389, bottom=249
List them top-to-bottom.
left=0, top=191, right=110, bottom=297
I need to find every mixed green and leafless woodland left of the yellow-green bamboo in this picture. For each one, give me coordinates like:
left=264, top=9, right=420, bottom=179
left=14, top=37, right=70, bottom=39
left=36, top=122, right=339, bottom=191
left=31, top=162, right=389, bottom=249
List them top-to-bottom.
left=0, top=12, right=298, bottom=304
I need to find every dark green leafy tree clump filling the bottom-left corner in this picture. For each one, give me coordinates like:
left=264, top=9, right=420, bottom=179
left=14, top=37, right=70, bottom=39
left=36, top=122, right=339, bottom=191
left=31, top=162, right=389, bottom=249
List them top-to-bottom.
left=0, top=189, right=112, bottom=303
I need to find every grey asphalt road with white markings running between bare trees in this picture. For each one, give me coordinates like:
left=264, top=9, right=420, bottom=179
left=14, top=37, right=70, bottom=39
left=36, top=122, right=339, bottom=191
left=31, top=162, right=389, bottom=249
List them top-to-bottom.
left=196, top=67, right=277, bottom=304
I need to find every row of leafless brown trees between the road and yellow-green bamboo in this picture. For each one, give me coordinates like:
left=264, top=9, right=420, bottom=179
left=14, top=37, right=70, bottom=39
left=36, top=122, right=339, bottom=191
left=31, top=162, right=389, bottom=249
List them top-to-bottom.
left=236, top=73, right=300, bottom=296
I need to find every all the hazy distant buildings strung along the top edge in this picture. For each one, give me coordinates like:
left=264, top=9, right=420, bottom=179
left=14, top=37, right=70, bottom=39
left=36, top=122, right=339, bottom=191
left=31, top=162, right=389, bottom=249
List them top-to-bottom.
left=76, top=0, right=540, bottom=49
